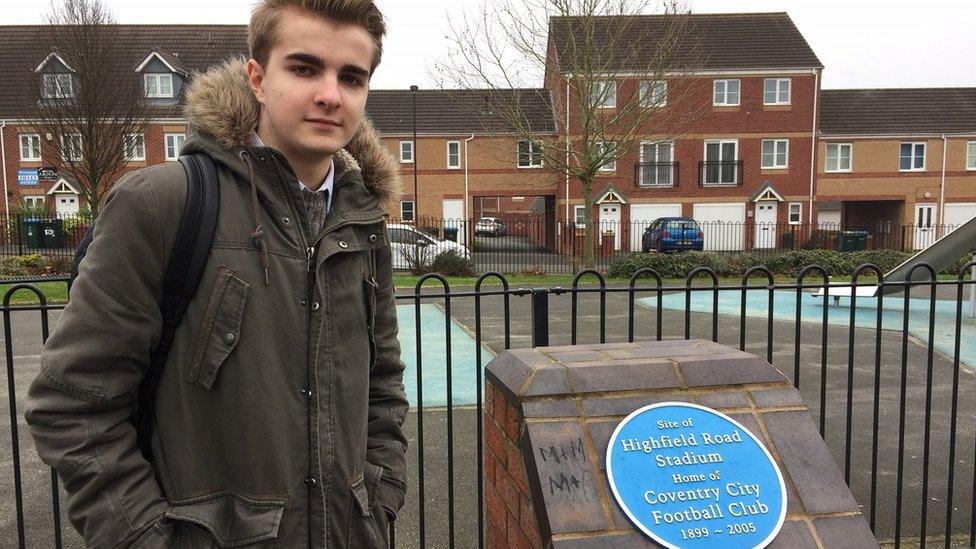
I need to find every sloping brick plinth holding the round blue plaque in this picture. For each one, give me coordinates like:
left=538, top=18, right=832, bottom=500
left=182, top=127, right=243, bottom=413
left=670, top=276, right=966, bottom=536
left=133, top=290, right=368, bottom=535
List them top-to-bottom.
left=485, top=340, right=878, bottom=549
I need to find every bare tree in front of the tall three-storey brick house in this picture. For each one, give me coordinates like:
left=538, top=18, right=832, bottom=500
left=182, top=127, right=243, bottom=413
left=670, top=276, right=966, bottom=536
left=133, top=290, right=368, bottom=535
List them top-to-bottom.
left=434, top=0, right=705, bottom=266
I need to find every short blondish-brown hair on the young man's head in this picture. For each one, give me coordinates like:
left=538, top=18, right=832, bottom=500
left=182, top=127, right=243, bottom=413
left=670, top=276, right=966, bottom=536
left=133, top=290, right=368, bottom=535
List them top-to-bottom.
left=247, top=0, right=386, bottom=72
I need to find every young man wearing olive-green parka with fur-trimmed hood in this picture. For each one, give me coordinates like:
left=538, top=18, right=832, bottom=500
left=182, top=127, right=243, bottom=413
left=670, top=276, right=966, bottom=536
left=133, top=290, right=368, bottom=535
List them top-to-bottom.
left=27, top=0, right=407, bottom=548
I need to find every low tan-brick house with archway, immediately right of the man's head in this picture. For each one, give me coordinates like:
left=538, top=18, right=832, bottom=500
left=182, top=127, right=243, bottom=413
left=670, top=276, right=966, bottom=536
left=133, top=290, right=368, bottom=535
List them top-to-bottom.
left=366, top=89, right=557, bottom=244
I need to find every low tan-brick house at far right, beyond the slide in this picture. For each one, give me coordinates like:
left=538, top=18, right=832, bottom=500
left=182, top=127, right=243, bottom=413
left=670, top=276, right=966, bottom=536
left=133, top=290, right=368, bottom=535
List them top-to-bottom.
left=817, top=88, right=976, bottom=249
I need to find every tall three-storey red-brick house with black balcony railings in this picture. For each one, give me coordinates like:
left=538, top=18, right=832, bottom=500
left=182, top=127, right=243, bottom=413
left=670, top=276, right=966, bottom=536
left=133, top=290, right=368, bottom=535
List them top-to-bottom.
left=545, top=13, right=823, bottom=250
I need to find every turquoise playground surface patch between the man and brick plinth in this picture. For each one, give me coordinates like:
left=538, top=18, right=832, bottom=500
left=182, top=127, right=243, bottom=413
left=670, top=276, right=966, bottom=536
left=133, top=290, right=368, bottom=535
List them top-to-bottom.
left=396, top=303, right=495, bottom=407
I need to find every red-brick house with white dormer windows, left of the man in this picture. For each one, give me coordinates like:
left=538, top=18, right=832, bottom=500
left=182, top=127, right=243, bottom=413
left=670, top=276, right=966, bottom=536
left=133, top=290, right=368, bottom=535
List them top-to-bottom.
left=0, top=25, right=247, bottom=215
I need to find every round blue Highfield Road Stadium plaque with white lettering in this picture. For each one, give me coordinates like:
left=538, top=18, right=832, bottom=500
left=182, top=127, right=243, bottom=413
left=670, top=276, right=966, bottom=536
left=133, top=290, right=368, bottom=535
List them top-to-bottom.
left=607, top=402, right=786, bottom=549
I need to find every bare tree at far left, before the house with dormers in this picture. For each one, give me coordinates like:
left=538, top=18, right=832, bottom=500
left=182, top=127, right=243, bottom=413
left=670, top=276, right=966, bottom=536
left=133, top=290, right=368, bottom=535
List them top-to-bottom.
left=28, top=0, right=152, bottom=216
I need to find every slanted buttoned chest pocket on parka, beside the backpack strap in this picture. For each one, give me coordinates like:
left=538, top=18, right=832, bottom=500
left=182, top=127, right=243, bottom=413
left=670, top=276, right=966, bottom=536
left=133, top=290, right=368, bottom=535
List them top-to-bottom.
left=186, top=267, right=250, bottom=389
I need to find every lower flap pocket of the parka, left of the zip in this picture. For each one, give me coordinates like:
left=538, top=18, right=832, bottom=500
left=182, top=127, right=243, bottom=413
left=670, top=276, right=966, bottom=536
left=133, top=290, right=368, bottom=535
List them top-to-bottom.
left=166, top=491, right=286, bottom=547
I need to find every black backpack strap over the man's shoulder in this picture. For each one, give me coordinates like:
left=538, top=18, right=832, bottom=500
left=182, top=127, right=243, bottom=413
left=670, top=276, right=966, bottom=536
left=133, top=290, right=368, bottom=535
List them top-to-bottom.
left=136, top=153, right=220, bottom=462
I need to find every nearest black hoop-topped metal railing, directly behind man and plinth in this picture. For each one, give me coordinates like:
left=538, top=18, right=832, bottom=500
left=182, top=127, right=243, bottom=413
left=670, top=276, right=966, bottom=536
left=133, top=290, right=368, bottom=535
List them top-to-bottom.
left=0, top=263, right=976, bottom=548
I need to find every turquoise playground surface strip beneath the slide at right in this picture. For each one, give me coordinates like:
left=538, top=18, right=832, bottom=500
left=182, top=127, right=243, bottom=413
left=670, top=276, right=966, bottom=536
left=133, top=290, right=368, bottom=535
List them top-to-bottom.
left=637, top=289, right=976, bottom=368
